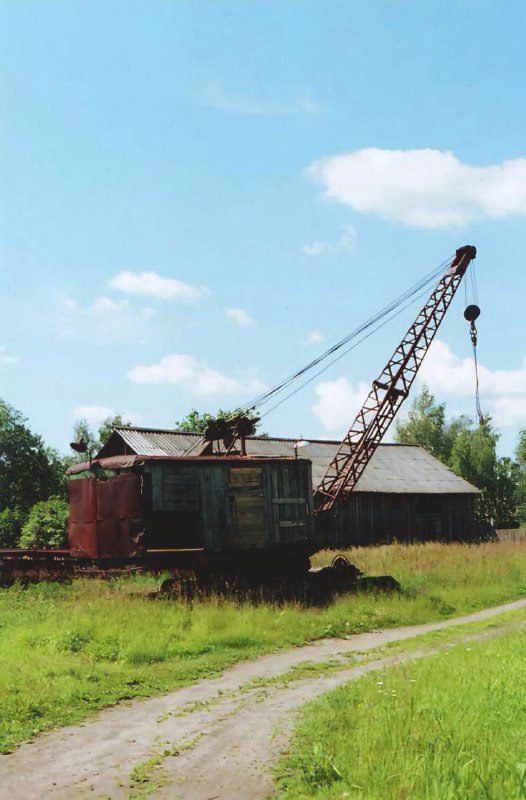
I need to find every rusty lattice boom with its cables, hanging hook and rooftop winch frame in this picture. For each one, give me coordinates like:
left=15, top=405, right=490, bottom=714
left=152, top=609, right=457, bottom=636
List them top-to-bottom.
left=196, top=250, right=485, bottom=462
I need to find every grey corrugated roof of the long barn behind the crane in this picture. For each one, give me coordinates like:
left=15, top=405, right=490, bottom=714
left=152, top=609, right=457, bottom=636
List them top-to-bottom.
left=97, top=427, right=478, bottom=494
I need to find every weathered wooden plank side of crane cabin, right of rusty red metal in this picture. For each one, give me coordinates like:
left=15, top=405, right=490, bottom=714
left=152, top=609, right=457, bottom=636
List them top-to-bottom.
left=141, top=458, right=314, bottom=552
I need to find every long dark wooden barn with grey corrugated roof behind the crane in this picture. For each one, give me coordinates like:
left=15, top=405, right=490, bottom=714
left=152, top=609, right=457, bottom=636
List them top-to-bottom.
left=97, top=427, right=479, bottom=547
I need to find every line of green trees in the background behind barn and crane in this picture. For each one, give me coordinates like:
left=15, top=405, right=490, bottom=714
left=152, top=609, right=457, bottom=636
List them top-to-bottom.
left=0, top=388, right=526, bottom=547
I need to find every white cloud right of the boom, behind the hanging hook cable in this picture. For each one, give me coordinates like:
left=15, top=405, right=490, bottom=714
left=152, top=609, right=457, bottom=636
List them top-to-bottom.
left=419, top=340, right=526, bottom=428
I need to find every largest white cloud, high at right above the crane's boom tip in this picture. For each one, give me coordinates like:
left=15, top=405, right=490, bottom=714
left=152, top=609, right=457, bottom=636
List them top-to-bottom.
left=307, top=147, right=526, bottom=228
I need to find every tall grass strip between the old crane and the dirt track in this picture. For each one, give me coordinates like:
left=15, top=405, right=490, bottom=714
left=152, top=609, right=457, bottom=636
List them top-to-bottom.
left=0, top=542, right=526, bottom=753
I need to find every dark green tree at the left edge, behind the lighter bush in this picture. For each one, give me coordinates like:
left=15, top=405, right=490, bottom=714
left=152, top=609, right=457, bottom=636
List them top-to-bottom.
left=0, top=400, right=64, bottom=514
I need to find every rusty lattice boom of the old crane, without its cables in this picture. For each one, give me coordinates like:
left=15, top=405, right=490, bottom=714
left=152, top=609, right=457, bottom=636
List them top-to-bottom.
left=314, top=245, right=477, bottom=516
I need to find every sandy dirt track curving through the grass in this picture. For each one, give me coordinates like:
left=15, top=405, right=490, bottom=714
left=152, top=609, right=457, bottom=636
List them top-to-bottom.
left=0, top=600, right=526, bottom=800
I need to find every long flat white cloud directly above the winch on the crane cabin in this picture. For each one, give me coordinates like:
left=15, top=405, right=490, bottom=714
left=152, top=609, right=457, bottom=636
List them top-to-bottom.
left=128, top=353, right=265, bottom=396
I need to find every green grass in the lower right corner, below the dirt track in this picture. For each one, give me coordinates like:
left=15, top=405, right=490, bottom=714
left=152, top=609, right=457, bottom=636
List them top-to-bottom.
left=278, top=630, right=526, bottom=800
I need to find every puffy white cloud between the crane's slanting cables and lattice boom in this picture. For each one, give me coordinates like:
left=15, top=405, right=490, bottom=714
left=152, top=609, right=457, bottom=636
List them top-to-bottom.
left=312, top=377, right=370, bottom=436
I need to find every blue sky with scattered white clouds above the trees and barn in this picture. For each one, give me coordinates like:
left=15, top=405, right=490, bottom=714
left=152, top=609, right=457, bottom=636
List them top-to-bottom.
left=0, top=0, right=526, bottom=455
